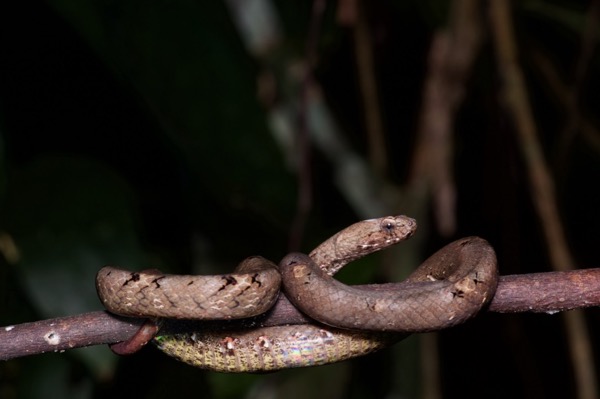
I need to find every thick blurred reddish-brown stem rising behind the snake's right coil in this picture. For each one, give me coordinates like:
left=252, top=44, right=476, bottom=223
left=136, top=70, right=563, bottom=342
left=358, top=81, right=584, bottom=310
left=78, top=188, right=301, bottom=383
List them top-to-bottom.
left=410, top=0, right=481, bottom=236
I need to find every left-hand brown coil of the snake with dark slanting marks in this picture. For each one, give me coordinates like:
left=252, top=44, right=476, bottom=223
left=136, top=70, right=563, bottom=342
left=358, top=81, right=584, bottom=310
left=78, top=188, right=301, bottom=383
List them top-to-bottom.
left=96, top=256, right=281, bottom=320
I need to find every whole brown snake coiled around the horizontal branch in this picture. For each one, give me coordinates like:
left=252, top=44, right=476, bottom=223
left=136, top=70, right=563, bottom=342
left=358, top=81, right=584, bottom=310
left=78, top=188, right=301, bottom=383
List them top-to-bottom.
left=97, top=216, right=497, bottom=372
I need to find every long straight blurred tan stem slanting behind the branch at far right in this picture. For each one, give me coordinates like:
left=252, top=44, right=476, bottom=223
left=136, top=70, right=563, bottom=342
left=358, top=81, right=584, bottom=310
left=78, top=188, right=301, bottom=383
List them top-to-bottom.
left=490, top=0, right=598, bottom=399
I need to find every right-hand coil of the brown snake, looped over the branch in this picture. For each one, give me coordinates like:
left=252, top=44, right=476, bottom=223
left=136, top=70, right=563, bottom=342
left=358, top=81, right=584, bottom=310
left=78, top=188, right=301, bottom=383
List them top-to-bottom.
left=280, top=237, right=498, bottom=333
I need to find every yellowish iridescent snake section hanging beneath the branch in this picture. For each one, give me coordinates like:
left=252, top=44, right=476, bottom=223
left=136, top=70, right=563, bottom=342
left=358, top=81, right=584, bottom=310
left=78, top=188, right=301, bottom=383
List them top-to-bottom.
left=154, top=324, right=402, bottom=373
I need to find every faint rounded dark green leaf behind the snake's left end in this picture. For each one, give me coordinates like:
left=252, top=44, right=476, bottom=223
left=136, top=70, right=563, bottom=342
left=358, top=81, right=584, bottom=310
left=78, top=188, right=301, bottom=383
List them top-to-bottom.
left=2, top=157, right=145, bottom=375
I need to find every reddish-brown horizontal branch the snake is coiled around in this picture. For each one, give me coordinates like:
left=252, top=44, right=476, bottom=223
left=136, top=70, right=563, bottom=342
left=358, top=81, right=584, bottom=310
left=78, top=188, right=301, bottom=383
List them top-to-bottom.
left=0, top=268, right=600, bottom=360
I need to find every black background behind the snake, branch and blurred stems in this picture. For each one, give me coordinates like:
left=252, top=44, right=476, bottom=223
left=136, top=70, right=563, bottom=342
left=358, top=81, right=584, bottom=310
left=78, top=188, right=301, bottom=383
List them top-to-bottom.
left=0, top=0, right=600, bottom=398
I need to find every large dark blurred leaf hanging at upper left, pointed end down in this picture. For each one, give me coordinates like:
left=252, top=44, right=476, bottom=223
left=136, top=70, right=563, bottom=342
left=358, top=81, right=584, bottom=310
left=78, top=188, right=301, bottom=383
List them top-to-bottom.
left=50, top=0, right=295, bottom=219
